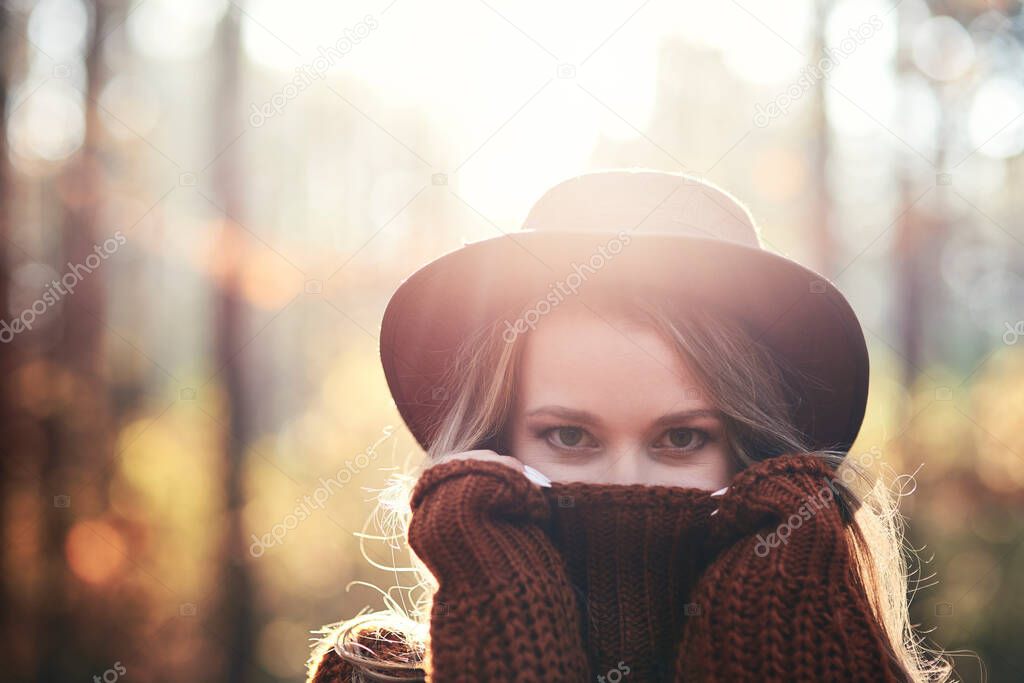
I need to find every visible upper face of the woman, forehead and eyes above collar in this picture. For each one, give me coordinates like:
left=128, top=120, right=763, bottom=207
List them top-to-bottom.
left=511, top=306, right=735, bottom=490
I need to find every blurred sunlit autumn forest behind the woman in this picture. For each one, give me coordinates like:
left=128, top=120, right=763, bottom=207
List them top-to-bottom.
left=0, top=0, right=1024, bottom=683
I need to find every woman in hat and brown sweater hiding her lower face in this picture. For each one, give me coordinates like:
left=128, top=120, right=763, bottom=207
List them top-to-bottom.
left=310, top=170, right=948, bottom=682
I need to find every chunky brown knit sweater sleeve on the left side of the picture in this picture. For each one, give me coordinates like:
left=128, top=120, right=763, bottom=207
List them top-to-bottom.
left=409, top=460, right=588, bottom=683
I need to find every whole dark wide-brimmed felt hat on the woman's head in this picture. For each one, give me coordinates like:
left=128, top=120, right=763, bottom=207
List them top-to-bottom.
left=380, top=169, right=868, bottom=451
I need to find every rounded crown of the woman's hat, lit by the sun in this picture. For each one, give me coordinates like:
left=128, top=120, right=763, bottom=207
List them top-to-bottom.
left=522, top=170, right=761, bottom=248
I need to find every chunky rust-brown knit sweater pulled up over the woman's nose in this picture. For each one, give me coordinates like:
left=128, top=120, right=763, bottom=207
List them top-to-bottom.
left=310, top=456, right=907, bottom=683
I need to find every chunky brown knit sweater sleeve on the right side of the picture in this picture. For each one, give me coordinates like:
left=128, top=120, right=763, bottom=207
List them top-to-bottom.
left=677, top=456, right=907, bottom=681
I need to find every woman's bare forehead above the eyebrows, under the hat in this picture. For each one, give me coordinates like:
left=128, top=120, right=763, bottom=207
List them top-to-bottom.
left=519, top=306, right=711, bottom=419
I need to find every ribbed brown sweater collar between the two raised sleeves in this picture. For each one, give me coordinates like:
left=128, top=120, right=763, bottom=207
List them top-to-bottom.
left=543, top=482, right=717, bottom=681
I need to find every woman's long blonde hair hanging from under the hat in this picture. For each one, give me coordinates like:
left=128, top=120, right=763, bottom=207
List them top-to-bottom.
left=309, top=286, right=951, bottom=681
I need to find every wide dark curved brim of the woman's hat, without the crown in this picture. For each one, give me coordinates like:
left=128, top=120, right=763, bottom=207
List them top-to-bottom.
left=380, top=230, right=868, bottom=451
